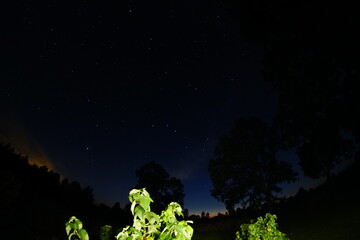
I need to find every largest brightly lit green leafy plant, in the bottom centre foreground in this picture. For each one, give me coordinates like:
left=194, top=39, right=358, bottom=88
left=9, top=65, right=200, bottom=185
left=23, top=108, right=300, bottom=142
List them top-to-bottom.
left=116, top=188, right=193, bottom=240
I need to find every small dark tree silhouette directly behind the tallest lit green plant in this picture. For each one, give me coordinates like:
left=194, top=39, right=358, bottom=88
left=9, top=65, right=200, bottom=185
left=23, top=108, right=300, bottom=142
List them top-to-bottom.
left=136, top=162, right=185, bottom=213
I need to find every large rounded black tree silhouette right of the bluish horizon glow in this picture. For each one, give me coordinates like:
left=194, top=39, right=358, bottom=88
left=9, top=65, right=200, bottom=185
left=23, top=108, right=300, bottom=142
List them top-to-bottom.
left=209, top=118, right=296, bottom=214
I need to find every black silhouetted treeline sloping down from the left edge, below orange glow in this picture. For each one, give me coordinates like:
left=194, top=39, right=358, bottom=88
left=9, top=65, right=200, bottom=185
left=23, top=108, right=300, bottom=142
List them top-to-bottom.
left=0, top=143, right=131, bottom=239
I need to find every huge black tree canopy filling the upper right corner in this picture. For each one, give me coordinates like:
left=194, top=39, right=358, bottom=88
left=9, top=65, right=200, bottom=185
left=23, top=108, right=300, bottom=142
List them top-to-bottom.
left=225, top=0, right=360, bottom=178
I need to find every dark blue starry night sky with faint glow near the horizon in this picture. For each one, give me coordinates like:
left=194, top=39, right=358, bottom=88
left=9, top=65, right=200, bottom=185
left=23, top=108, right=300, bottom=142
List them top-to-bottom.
left=0, top=0, right=320, bottom=214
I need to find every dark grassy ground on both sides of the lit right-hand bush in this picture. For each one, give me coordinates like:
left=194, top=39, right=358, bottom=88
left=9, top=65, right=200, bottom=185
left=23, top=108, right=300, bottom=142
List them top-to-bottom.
left=192, top=202, right=360, bottom=240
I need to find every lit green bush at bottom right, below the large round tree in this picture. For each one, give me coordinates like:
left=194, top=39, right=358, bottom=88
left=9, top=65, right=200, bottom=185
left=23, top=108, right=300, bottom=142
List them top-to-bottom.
left=235, top=213, right=289, bottom=240
